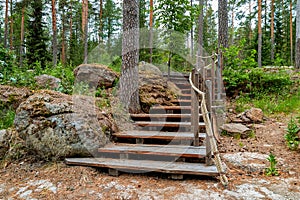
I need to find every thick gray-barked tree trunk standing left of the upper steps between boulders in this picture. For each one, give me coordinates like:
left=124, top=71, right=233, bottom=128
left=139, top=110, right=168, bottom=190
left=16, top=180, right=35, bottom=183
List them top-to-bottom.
left=120, top=0, right=140, bottom=113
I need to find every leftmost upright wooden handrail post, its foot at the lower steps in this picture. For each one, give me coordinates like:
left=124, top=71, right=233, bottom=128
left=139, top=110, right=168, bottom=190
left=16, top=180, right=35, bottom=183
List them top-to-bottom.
left=191, top=69, right=199, bottom=146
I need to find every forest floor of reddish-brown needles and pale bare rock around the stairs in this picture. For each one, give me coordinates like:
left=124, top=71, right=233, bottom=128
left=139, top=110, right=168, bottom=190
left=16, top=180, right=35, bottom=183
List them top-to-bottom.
left=0, top=116, right=300, bottom=200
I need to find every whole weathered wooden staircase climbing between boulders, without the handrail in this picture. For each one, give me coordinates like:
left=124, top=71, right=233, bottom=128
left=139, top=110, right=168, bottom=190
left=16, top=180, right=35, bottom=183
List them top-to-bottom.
left=65, top=73, right=219, bottom=179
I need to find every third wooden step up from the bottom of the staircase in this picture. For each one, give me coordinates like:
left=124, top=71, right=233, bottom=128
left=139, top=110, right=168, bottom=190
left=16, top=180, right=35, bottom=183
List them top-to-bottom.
left=113, top=131, right=206, bottom=141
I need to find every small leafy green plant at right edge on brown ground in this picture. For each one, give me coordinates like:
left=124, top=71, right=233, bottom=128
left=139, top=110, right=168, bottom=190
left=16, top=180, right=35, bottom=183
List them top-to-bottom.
left=284, top=118, right=300, bottom=150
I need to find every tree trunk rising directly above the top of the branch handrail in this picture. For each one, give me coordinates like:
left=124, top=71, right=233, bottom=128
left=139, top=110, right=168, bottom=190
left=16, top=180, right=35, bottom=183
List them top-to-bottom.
left=218, top=0, right=228, bottom=48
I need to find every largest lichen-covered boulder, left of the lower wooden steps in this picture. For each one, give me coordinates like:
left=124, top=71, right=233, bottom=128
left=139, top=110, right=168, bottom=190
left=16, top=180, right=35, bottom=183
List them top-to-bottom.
left=14, top=90, right=115, bottom=160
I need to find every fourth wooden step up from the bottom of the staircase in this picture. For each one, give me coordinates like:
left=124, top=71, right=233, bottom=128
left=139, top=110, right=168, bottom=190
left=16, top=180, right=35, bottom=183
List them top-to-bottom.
left=134, top=121, right=205, bottom=128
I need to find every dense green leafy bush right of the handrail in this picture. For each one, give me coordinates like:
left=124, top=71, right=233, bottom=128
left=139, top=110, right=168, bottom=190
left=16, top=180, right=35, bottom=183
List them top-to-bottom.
left=223, top=40, right=293, bottom=97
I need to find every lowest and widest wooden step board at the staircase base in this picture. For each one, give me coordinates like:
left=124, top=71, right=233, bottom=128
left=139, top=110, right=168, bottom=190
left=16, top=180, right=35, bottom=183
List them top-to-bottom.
left=65, top=158, right=218, bottom=176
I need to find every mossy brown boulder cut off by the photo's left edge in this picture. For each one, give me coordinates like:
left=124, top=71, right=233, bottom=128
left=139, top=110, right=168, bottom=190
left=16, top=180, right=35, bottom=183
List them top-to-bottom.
left=0, top=85, right=32, bottom=109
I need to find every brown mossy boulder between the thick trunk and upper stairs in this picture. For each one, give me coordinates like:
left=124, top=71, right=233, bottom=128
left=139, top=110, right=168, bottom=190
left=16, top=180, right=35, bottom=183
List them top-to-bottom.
left=139, top=62, right=181, bottom=113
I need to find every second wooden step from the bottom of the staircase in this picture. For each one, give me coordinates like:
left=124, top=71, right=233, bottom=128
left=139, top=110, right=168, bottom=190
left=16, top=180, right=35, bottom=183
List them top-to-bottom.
left=98, top=144, right=206, bottom=158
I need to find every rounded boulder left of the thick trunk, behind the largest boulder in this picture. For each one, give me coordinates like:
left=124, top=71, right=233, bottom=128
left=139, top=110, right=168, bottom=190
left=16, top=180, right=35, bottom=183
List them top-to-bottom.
left=74, top=64, right=118, bottom=88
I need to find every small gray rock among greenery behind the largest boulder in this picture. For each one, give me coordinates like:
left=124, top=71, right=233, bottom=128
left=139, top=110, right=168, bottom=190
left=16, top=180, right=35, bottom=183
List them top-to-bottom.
left=34, top=74, right=61, bottom=90
